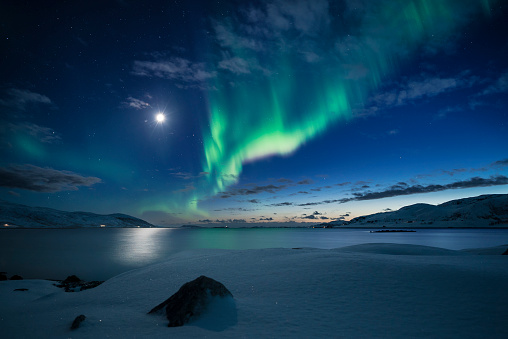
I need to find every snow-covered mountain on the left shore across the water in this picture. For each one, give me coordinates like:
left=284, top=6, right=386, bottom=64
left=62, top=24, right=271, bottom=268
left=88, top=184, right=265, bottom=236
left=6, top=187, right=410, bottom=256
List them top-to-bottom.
left=0, top=200, right=154, bottom=228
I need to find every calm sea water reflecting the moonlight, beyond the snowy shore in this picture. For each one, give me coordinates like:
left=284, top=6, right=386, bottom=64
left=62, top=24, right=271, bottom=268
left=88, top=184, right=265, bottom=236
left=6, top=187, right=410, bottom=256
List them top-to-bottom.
left=0, top=228, right=508, bottom=280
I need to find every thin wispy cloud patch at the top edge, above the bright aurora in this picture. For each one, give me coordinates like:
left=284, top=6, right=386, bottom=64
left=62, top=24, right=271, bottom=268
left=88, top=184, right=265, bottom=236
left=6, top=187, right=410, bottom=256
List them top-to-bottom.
left=212, top=0, right=331, bottom=69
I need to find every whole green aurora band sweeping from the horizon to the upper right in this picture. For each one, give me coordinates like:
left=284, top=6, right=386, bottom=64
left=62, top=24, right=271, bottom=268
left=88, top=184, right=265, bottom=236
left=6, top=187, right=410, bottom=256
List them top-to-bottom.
left=146, top=0, right=494, bottom=217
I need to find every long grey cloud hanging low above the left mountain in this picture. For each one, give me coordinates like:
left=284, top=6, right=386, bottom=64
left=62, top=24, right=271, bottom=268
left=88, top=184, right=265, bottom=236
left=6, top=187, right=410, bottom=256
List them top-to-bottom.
left=0, top=164, right=101, bottom=193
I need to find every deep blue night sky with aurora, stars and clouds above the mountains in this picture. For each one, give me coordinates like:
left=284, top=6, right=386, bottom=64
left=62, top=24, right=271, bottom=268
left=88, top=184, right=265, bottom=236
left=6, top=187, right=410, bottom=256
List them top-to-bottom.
left=0, top=0, right=508, bottom=226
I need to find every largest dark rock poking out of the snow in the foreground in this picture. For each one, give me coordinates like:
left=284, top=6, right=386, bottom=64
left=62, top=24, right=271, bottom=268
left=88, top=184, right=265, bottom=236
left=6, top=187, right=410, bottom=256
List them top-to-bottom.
left=148, top=275, right=233, bottom=327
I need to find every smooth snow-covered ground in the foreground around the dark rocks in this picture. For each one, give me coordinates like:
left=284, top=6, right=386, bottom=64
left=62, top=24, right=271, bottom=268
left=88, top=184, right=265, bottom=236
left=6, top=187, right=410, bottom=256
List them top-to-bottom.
left=0, top=244, right=508, bottom=339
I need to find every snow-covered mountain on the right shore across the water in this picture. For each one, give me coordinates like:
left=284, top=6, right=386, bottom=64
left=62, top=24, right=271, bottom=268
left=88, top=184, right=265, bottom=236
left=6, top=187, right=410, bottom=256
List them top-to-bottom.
left=322, top=194, right=508, bottom=227
